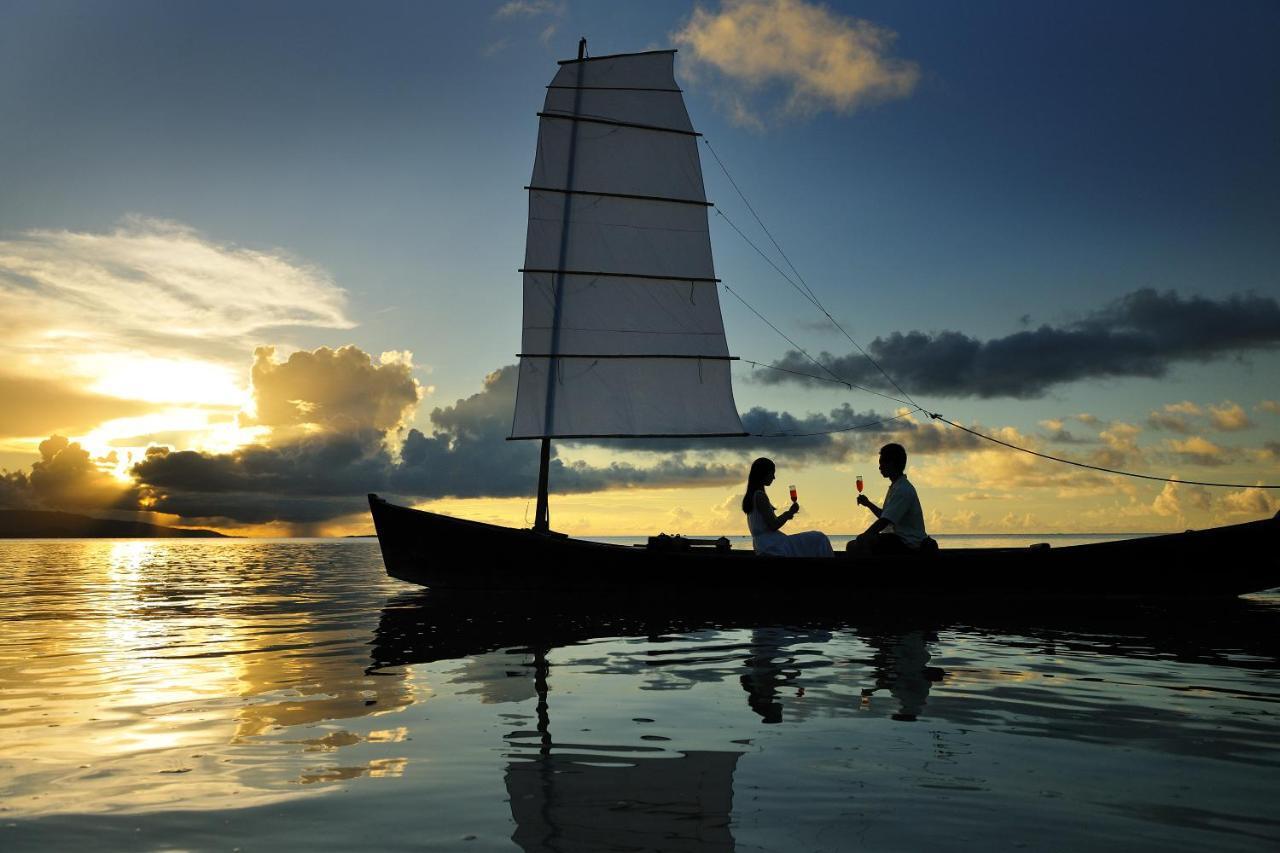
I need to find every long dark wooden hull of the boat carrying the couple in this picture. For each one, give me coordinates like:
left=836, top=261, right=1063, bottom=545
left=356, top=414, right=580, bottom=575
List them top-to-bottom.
left=369, top=494, right=1280, bottom=598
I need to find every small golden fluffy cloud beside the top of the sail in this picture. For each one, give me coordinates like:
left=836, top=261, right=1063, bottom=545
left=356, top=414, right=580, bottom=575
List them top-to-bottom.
left=672, top=0, right=920, bottom=126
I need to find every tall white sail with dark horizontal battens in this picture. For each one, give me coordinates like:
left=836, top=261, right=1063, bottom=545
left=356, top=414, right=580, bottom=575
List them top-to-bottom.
left=511, top=50, right=744, bottom=438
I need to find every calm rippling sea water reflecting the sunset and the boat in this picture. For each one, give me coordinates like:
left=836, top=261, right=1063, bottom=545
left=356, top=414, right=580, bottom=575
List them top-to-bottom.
left=0, top=539, right=1280, bottom=852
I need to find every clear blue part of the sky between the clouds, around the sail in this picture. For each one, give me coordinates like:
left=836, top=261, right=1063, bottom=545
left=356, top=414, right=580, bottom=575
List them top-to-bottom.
left=0, top=0, right=1280, bottom=532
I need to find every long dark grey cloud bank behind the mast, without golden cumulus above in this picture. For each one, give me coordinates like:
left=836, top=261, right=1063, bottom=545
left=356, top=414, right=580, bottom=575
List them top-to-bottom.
left=124, top=356, right=978, bottom=524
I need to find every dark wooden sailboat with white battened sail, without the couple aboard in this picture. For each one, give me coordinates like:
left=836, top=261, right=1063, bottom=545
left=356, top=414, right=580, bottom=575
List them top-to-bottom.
left=369, top=42, right=1280, bottom=596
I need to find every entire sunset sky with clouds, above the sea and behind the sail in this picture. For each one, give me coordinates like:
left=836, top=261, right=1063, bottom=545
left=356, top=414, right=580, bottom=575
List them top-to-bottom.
left=0, top=0, right=1280, bottom=535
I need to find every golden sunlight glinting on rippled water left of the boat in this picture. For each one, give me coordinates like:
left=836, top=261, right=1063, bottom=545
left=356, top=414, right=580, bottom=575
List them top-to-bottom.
left=0, top=540, right=414, bottom=816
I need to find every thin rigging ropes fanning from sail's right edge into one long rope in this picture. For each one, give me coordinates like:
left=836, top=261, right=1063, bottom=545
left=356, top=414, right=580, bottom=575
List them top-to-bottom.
left=703, top=137, right=1280, bottom=489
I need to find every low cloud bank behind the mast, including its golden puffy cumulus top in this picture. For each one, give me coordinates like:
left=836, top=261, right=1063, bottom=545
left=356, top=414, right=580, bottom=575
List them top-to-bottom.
left=117, top=347, right=979, bottom=526
